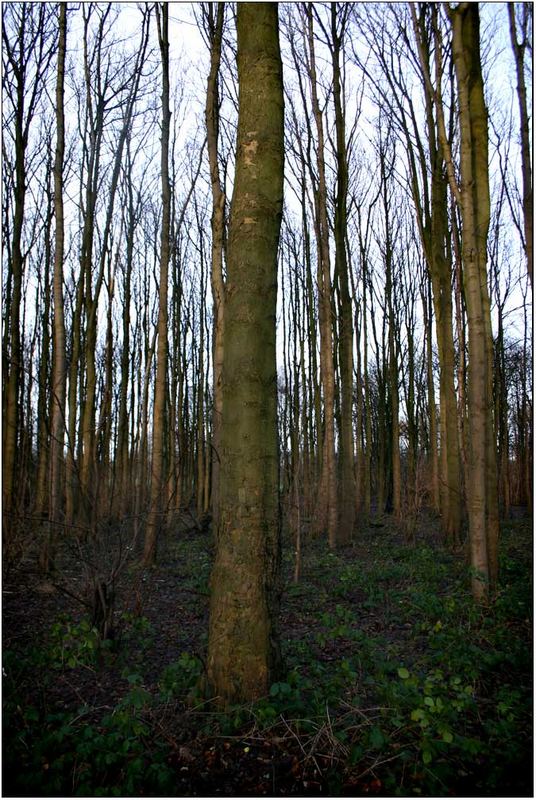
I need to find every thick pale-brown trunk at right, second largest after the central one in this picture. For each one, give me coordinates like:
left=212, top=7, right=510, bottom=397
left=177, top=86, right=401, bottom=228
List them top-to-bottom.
left=449, top=3, right=499, bottom=600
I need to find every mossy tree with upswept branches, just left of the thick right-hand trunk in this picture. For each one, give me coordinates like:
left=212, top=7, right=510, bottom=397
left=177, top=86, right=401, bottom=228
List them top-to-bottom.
left=362, top=4, right=462, bottom=541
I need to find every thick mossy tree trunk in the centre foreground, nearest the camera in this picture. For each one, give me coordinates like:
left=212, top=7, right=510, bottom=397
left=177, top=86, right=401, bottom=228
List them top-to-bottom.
left=207, top=3, right=284, bottom=704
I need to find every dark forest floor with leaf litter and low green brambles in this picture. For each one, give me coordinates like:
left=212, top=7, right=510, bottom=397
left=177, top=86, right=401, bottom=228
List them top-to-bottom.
left=2, top=510, right=533, bottom=797
